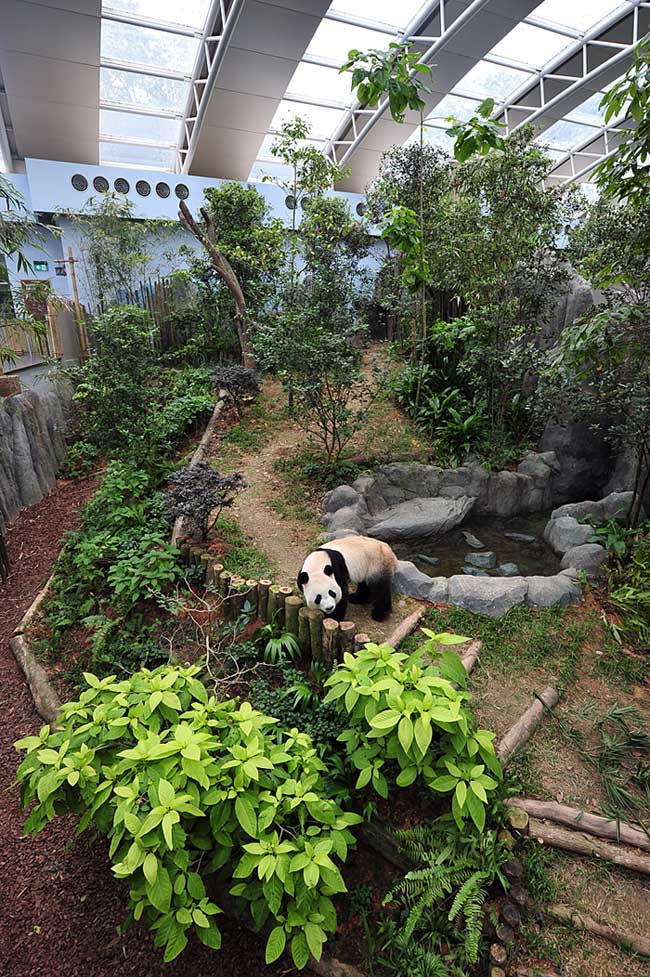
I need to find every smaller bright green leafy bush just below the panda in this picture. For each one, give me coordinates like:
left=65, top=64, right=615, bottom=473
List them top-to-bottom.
left=325, top=629, right=501, bottom=831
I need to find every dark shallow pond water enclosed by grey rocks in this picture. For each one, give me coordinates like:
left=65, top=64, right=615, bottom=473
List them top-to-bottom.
left=393, top=512, right=560, bottom=577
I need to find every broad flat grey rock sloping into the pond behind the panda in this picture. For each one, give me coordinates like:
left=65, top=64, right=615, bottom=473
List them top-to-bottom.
left=368, top=496, right=475, bottom=543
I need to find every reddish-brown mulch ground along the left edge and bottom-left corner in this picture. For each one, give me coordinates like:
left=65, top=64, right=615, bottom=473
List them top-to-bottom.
left=0, top=481, right=295, bottom=977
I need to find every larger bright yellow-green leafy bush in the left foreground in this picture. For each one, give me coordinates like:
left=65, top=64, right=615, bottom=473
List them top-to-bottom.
left=16, top=666, right=360, bottom=968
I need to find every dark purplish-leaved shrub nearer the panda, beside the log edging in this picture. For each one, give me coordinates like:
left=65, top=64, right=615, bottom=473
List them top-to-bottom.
left=166, top=461, right=246, bottom=540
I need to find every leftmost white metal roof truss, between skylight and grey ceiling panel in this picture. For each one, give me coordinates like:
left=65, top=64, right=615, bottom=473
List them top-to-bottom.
left=177, top=0, right=245, bottom=173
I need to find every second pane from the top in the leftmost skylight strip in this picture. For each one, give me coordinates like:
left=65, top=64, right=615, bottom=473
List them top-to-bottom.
left=101, top=20, right=199, bottom=75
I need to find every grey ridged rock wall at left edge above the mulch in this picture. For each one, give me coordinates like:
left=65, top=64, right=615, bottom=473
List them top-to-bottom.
left=0, top=389, right=71, bottom=531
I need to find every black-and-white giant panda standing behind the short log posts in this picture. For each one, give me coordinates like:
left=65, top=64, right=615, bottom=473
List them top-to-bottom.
left=298, top=536, right=397, bottom=621
